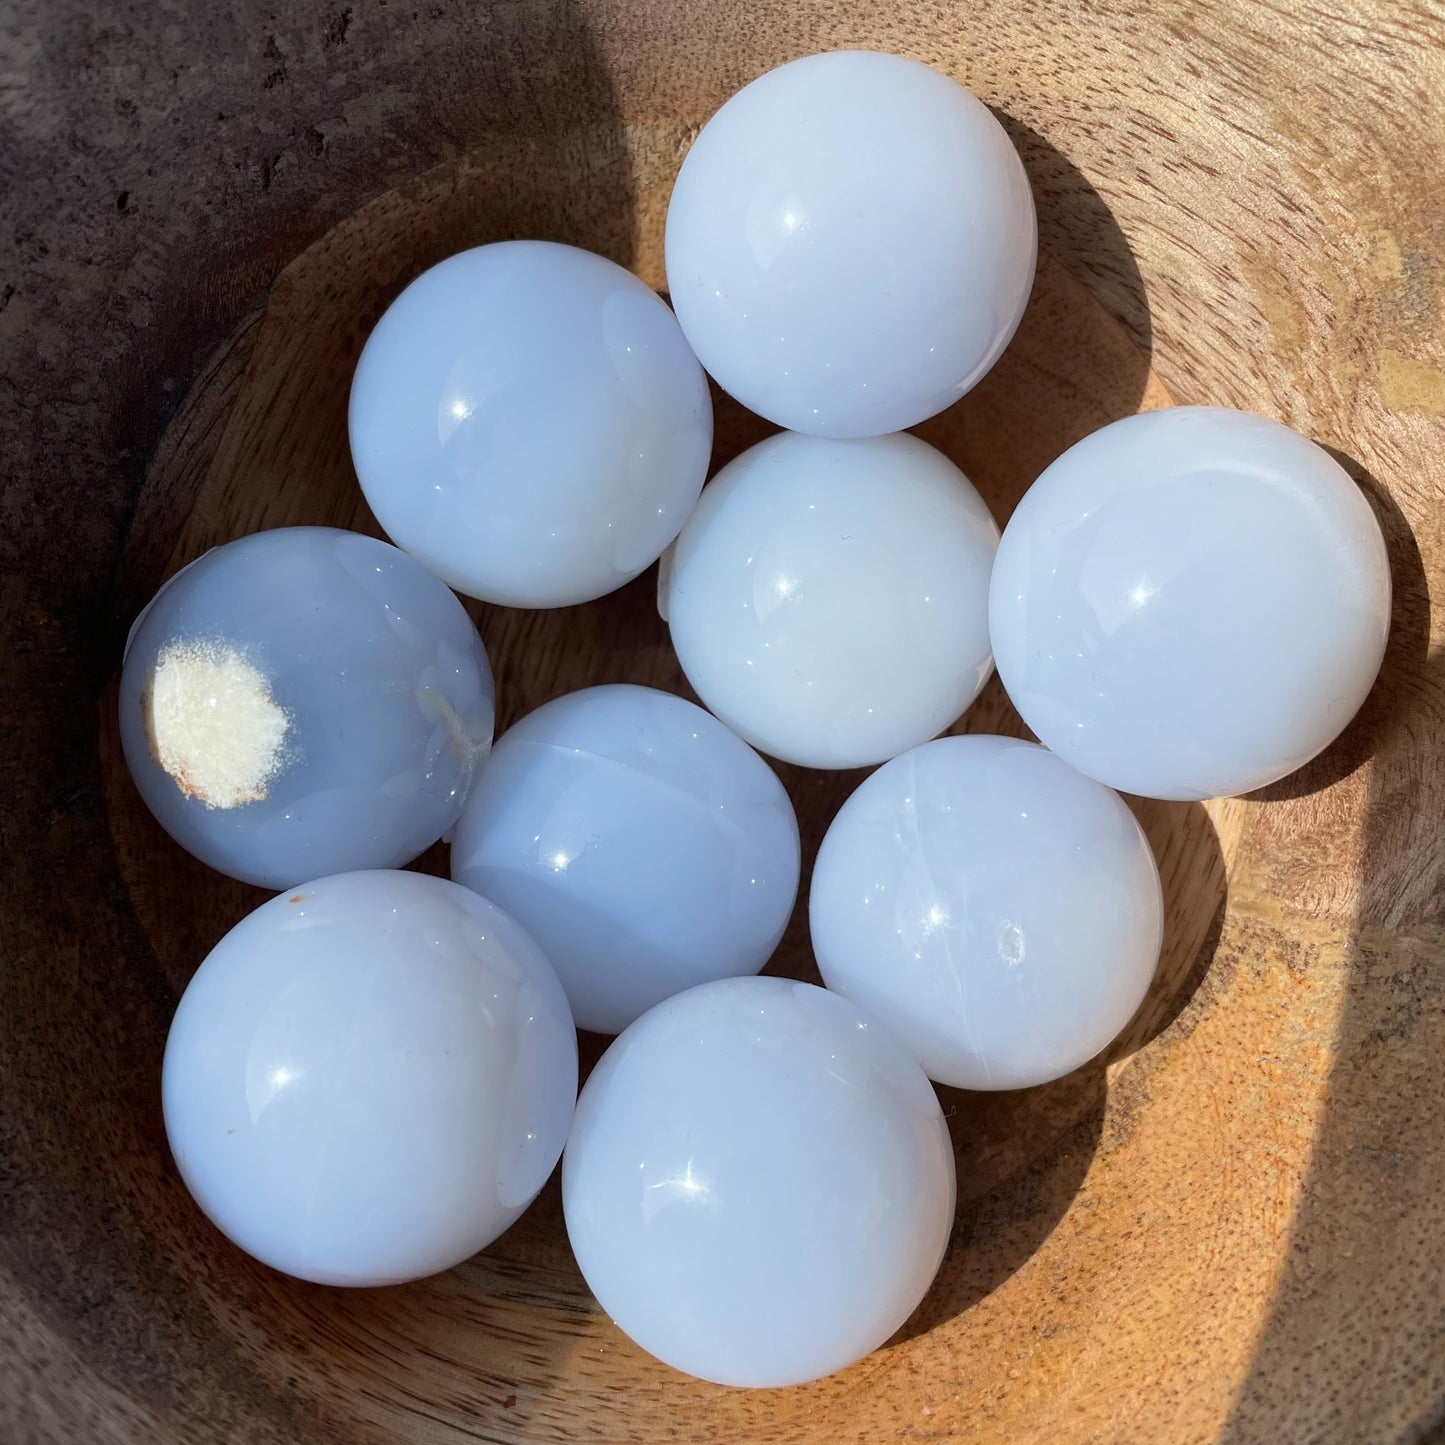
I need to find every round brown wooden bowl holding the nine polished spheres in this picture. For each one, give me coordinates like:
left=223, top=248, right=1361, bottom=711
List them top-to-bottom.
left=0, top=0, right=1445, bottom=1445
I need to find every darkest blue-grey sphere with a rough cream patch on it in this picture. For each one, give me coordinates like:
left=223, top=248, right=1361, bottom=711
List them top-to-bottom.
left=120, top=527, right=496, bottom=889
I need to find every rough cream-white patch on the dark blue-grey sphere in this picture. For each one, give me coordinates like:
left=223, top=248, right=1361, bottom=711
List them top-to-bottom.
left=140, top=640, right=290, bottom=808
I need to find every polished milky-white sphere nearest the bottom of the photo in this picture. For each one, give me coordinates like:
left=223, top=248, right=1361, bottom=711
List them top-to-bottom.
left=562, top=978, right=954, bottom=1386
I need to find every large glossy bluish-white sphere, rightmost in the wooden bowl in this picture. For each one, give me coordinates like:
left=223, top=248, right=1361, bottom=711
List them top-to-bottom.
left=990, top=406, right=1390, bottom=799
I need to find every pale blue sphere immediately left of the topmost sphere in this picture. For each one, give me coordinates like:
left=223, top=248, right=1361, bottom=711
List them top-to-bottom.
left=351, top=241, right=712, bottom=607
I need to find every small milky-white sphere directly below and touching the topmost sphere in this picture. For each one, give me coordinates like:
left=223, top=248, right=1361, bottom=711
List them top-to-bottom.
left=660, top=432, right=998, bottom=767
